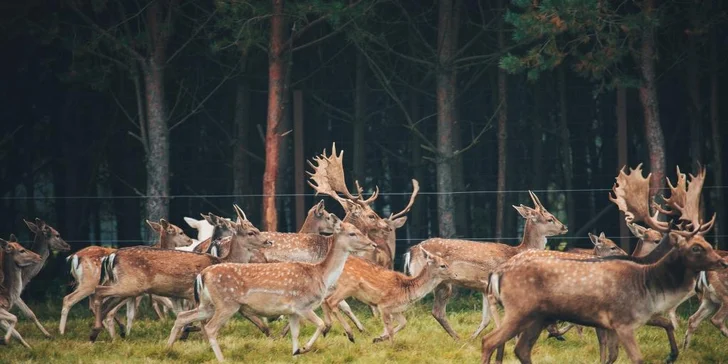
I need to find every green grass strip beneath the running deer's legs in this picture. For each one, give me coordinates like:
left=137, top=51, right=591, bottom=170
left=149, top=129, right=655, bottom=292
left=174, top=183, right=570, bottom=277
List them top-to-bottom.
left=0, top=296, right=728, bottom=364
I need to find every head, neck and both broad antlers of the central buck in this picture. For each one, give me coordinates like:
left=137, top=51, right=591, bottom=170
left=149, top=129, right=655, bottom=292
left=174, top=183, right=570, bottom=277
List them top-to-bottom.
left=307, top=143, right=420, bottom=266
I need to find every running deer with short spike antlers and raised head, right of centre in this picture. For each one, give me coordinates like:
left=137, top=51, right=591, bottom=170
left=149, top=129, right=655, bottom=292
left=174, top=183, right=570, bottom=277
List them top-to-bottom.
left=405, top=191, right=568, bottom=340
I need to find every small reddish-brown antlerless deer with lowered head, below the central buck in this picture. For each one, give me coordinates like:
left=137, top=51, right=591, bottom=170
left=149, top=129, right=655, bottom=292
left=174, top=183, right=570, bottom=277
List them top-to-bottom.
left=322, top=250, right=457, bottom=343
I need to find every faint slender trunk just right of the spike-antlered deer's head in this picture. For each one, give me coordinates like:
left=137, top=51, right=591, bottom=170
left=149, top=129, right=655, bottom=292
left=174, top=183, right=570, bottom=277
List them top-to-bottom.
left=558, top=67, right=576, bottom=233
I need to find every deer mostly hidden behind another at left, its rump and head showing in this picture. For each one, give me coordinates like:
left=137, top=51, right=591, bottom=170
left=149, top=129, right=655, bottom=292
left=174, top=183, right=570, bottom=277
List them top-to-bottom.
left=58, top=219, right=192, bottom=336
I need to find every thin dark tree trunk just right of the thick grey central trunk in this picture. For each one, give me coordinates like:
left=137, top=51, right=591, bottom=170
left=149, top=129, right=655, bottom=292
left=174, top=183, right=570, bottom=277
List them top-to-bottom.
left=495, top=0, right=508, bottom=240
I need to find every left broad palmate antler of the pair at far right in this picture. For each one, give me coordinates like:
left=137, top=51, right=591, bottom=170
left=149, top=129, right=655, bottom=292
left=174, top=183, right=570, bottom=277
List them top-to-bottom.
left=609, top=163, right=670, bottom=232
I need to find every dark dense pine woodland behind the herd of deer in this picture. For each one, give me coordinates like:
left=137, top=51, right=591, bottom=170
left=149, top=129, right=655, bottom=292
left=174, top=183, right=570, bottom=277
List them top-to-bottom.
left=0, top=0, right=728, bottom=302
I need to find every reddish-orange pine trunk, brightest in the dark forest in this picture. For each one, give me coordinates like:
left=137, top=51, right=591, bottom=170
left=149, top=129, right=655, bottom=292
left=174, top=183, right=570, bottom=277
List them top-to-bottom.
left=262, top=0, right=288, bottom=231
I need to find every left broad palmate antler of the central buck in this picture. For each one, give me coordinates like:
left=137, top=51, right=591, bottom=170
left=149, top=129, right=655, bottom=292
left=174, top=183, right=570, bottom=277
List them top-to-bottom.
left=307, top=143, right=379, bottom=206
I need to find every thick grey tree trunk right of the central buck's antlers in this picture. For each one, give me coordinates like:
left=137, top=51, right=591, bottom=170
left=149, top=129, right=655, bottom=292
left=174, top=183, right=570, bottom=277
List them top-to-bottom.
left=436, top=0, right=457, bottom=238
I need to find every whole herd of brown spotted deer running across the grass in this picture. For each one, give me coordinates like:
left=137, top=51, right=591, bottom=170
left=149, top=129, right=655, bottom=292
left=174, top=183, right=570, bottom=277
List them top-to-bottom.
left=0, top=145, right=728, bottom=363
